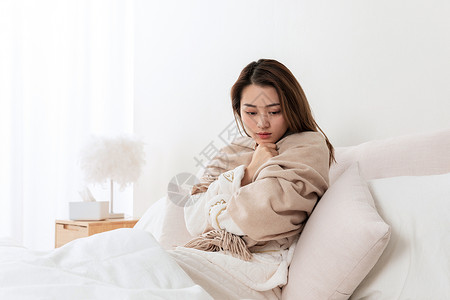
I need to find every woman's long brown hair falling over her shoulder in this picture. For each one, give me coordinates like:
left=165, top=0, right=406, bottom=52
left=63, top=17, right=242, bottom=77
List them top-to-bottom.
left=231, top=59, right=336, bottom=165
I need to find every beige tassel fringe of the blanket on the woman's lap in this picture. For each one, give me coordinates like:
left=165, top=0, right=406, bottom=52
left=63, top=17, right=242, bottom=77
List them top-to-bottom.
left=184, top=230, right=253, bottom=261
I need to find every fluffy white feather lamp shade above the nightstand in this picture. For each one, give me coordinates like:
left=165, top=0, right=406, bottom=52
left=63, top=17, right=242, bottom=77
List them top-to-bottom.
left=80, top=135, right=145, bottom=189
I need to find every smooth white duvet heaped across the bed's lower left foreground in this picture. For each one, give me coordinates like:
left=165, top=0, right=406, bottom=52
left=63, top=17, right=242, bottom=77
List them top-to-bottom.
left=0, top=229, right=212, bottom=299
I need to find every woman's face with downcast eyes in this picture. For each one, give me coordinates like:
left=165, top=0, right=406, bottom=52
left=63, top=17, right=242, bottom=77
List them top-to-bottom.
left=240, top=84, right=288, bottom=144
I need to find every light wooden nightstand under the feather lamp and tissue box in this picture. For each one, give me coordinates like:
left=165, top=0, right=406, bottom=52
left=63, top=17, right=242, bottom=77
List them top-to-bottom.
left=55, top=219, right=138, bottom=248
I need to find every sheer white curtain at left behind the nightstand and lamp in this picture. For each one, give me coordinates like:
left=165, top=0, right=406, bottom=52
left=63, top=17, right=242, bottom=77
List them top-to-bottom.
left=0, top=0, right=134, bottom=249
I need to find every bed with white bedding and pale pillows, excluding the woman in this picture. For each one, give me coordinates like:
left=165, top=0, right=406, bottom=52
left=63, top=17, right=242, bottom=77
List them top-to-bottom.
left=0, top=130, right=450, bottom=299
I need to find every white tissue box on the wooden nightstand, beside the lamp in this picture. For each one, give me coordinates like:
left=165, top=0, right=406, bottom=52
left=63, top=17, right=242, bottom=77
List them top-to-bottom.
left=69, top=201, right=109, bottom=221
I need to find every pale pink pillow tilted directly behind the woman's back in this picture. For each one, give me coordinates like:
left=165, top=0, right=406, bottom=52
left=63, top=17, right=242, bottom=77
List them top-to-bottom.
left=282, top=164, right=390, bottom=300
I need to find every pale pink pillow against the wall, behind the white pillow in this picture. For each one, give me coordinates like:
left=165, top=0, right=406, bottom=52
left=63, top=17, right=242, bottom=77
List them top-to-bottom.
left=330, top=128, right=450, bottom=183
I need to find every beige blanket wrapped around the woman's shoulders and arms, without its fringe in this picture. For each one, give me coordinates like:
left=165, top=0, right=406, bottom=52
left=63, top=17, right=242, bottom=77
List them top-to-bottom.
left=192, top=132, right=329, bottom=247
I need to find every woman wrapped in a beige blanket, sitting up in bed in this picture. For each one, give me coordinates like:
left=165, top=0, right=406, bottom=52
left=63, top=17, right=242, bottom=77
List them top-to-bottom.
left=172, top=59, right=334, bottom=299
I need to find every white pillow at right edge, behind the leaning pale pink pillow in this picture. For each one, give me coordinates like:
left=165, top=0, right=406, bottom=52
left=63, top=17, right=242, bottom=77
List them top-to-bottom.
left=352, top=173, right=450, bottom=299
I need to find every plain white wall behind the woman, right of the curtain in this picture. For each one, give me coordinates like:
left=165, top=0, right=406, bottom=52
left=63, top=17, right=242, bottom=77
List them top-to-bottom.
left=134, top=0, right=450, bottom=216
